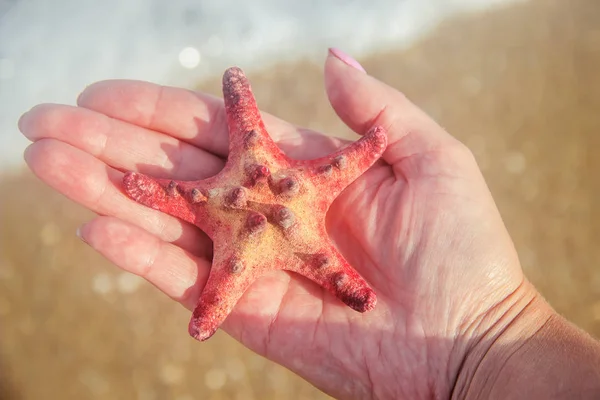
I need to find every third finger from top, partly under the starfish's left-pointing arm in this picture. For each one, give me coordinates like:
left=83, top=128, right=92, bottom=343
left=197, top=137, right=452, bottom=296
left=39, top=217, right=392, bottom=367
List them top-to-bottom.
left=25, top=139, right=212, bottom=255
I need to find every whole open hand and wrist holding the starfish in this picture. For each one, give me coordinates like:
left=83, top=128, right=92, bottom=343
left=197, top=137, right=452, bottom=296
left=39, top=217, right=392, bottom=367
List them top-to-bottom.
left=19, top=54, right=600, bottom=399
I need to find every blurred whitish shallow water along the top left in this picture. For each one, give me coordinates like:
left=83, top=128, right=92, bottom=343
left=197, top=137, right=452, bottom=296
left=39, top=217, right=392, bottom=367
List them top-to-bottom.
left=0, top=0, right=515, bottom=168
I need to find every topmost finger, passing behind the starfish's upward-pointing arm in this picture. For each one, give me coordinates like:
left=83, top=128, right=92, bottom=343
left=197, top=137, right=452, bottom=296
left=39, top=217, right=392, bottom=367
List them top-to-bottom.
left=77, top=80, right=300, bottom=157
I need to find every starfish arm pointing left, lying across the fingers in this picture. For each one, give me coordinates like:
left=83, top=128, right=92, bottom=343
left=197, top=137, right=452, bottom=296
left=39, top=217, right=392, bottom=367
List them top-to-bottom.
left=123, top=172, right=205, bottom=224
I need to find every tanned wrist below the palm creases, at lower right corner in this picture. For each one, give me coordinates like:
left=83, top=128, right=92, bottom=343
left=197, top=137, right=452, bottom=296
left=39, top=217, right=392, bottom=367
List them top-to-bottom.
left=452, top=284, right=600, bottom=399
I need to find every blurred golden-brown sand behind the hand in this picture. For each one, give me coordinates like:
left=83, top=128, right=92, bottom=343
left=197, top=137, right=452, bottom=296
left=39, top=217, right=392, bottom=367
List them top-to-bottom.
left=0, top=0, right=600, bottom=400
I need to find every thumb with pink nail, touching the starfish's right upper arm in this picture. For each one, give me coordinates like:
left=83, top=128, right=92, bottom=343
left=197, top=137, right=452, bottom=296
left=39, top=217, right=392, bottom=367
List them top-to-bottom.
left=325, top=49, right=458, bottom=165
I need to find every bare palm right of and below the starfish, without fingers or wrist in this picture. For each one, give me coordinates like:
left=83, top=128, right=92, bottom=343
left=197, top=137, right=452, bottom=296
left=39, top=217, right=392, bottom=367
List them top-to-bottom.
left=251, top=135, right=520, bottom=396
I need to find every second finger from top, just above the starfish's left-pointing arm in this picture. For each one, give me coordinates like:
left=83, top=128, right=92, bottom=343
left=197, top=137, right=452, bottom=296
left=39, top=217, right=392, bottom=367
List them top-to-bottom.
left=19, top=104, right=224, bottom=180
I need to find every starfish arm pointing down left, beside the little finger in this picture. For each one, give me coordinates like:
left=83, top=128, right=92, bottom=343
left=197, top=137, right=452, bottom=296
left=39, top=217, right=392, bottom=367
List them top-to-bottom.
left=188, top=253, right=256, bottom=341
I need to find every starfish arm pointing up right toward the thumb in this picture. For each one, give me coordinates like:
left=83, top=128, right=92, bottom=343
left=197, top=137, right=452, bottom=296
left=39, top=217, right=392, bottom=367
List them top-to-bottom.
left=291, top=126, right=387, bottom=199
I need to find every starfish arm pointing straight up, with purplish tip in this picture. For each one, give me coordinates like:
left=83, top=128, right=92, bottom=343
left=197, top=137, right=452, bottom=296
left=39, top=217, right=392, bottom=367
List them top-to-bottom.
left=223, top=67, right=285, bottom=161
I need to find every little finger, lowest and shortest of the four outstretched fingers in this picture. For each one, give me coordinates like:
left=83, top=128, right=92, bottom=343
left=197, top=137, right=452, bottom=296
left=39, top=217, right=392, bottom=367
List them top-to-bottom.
left=79, top=217, right=210, bottom=310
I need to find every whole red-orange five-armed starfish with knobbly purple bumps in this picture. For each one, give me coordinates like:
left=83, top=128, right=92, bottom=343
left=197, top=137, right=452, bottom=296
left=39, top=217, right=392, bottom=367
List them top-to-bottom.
left=123, top=67, right=387, bottom=341
